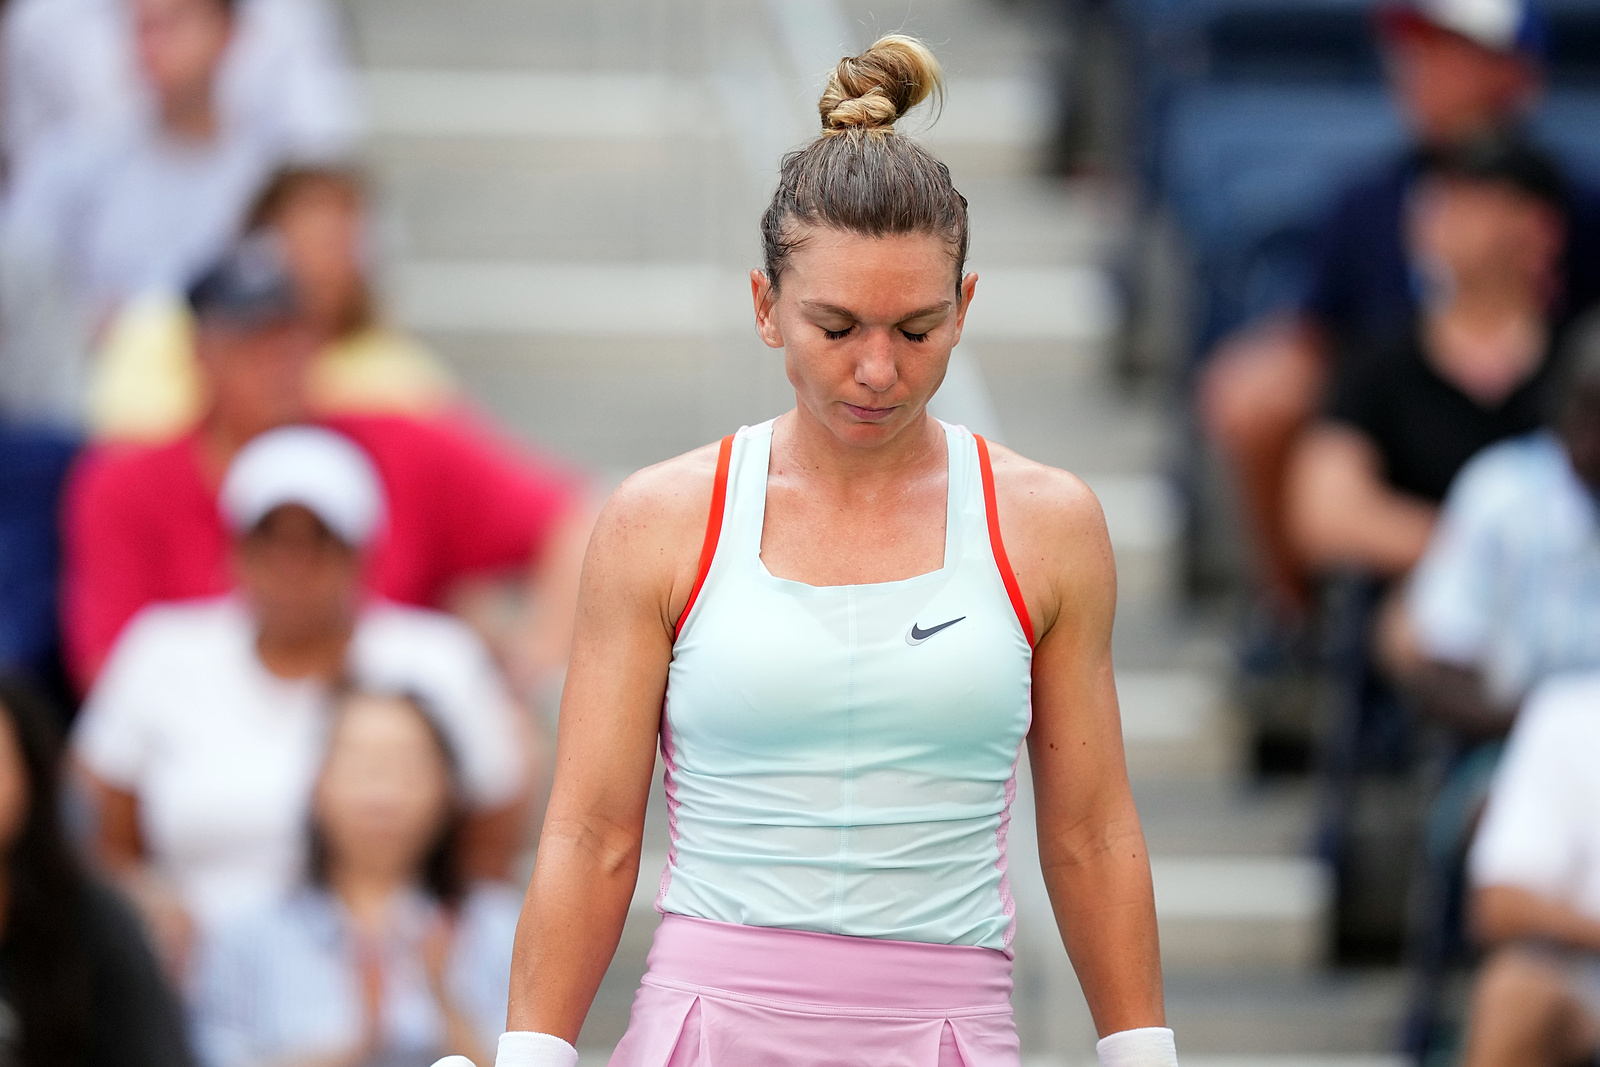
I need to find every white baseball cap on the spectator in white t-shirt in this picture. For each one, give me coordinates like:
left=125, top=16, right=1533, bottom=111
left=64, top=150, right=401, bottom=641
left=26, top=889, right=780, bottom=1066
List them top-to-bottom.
left=219, top=426, right=384, bottom=549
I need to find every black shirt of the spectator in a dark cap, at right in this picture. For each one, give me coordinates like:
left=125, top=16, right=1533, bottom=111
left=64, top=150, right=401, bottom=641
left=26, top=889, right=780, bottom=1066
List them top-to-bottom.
left=1326, top=326, right=1557, bottom=502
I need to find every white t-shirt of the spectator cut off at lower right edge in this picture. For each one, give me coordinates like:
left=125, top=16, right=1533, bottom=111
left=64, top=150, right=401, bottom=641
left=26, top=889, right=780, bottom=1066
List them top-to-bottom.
left=1469, top=672, right=1600, bottom=918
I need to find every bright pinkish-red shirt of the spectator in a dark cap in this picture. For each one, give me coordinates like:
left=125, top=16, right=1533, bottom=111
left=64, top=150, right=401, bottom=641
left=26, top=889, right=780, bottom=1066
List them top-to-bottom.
left=61, top=416, right=579, bottom=689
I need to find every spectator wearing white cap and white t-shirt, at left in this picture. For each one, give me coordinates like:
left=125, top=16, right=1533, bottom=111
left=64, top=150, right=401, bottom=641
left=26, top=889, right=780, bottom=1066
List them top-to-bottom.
left=74, top=427, right=528, bottom=973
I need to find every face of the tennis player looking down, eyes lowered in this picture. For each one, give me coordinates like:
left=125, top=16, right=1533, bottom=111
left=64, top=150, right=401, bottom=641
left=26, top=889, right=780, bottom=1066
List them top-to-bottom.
left=750, top=227, right=978, bottom=446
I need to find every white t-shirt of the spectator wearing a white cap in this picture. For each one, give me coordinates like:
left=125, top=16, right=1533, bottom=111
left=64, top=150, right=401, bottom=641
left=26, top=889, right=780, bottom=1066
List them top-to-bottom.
left=74, top=597, right=525, bottom=928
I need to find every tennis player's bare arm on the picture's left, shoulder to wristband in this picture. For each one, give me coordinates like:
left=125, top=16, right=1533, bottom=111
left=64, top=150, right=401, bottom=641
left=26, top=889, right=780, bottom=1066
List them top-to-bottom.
left=506, top=445, right=717, bottom=1043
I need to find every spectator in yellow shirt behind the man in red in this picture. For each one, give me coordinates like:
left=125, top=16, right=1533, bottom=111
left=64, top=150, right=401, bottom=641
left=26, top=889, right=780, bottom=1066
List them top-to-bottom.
left=90, top=166, right=458, bottom=442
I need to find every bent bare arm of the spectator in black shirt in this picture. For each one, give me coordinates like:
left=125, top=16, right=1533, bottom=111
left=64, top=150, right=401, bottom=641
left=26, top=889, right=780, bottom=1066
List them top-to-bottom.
left=1286, top=421, right=1437, bottom=577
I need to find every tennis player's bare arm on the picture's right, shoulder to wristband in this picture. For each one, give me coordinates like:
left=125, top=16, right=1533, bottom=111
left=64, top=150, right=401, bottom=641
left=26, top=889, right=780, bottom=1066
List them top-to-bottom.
left=995, top=450, right=1165, bottom=1037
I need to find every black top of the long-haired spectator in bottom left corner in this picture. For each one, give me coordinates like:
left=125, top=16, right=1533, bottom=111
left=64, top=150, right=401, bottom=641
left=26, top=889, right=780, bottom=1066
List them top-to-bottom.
left=0, top=885, right=194, bottom=1067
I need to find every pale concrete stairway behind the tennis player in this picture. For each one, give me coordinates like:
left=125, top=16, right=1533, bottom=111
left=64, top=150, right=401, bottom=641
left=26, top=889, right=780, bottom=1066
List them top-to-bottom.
left=334, top=0, right=1398, bottom=1067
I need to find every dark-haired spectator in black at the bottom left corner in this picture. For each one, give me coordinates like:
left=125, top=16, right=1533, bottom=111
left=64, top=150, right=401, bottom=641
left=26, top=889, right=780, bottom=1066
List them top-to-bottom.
left=0, top=681, right=192, bottom=1067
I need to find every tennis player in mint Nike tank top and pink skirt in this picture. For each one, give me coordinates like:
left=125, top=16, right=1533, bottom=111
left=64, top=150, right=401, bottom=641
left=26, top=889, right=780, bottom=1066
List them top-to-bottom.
left=460, top=37, right=1176, bottom=1067
